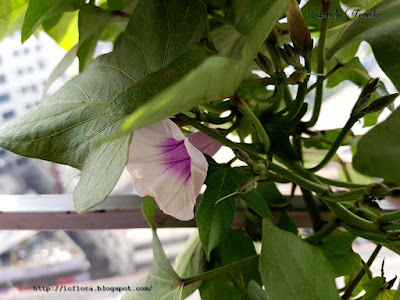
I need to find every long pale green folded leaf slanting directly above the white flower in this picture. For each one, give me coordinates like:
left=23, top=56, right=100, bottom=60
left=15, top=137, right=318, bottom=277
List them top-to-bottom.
left=124, top=0, right=287, bottom=130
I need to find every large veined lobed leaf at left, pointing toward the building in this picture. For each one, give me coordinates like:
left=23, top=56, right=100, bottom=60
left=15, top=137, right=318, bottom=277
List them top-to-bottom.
left=0, top=0, right=207, bottom=213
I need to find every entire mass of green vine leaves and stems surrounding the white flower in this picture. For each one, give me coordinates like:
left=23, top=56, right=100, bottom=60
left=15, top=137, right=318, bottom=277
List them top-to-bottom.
left=0, top=0, right=400, bottom=300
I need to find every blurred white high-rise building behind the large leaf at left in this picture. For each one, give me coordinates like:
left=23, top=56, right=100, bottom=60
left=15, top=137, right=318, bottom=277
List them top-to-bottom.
left=0, top=32, right=66, bottom=194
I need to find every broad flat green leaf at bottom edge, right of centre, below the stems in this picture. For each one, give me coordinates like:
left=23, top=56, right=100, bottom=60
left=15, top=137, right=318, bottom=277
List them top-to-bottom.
left=260, top=219, right=339, bottom=300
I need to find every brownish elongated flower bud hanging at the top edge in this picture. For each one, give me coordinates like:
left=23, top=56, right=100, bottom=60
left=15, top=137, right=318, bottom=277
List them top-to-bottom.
left=286, top=0, right=313, bottom=57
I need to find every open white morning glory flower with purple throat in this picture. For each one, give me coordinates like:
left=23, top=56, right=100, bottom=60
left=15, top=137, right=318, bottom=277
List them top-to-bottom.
left=126, top=119, right=221, bottom=220
